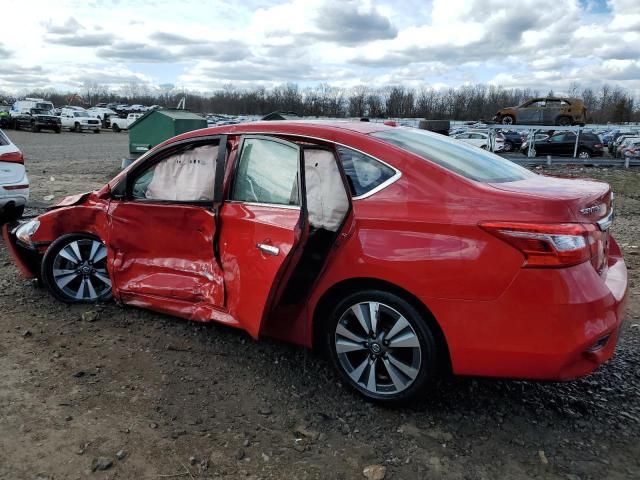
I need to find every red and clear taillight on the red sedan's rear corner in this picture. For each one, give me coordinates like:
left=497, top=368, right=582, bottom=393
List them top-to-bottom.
left=480, top=222, right=600, bottom=267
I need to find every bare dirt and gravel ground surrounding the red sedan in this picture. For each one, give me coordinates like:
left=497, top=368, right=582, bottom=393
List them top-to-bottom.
left=0, top=127, right=640, bottom=480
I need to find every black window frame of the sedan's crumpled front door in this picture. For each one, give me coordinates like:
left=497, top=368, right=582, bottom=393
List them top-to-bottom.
left=120, top=135, right=228, bottom=208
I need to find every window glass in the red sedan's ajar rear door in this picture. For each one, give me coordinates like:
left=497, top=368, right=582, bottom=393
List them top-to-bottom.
left=231, top=138, right=300, bottom=205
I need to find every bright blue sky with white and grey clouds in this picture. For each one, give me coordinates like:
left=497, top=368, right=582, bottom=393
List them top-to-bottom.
left=0, top=0, right=640, bottom=97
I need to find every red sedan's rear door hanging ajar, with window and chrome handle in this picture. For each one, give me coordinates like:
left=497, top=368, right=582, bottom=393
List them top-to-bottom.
left=220, top=135, right=306, bottom=338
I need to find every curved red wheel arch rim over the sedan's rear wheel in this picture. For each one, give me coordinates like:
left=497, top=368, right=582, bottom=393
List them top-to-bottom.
left=311, top=277, right=452, bottom=373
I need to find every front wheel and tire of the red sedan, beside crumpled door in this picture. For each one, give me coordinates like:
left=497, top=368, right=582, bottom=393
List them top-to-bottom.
left=40, top=233, right=111, bottom=303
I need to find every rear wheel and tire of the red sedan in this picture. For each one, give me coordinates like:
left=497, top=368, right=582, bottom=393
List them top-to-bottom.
left=325, top=290, right=439, bottom=405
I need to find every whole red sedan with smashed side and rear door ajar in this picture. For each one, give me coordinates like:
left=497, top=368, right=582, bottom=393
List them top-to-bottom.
left=4, top=122, right=627, bottom=403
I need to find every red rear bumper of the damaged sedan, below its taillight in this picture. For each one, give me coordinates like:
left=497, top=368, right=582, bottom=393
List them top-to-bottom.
left=432, top=235, right=627, bottom=380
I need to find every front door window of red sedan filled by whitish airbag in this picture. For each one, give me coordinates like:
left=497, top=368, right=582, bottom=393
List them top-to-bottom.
left=132, top=145, right=218, bottom=202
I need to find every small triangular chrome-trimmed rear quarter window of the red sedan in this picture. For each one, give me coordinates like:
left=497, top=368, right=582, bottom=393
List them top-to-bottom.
left=338, top=147, right=395, bottom=197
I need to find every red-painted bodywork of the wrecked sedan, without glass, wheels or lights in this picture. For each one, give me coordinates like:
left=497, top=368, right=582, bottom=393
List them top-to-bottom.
left=5, top=122, right=627, bottom=379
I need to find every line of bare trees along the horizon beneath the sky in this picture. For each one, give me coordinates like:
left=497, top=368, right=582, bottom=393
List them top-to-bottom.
left=0, top=83, right=640, bottom=123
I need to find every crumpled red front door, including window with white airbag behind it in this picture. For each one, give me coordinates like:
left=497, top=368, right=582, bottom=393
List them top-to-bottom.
left=108, top=137, right=225, bottom=320
